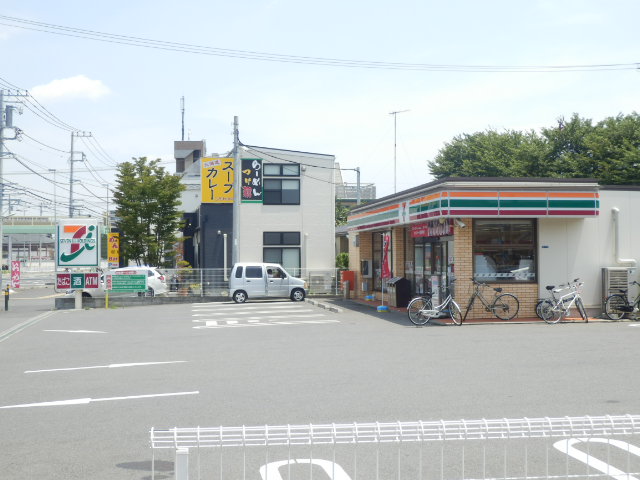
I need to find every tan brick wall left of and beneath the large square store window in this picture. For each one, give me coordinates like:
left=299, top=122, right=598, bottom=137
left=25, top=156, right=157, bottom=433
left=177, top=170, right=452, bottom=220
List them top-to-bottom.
left=454, top=218, right=538, bottom=318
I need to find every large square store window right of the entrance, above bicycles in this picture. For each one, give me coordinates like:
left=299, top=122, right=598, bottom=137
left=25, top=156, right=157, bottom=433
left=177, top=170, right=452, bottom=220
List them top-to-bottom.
left=473, top=219, right=537, bottom=282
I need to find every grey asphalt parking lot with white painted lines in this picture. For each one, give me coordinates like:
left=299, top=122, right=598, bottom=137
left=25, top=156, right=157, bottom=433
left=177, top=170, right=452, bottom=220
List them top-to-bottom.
left=0, top=286, right=640, bottom=480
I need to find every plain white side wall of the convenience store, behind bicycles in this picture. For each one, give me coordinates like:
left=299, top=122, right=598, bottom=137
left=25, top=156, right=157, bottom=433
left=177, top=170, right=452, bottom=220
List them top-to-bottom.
left=538, top=190, right=640, bottom=308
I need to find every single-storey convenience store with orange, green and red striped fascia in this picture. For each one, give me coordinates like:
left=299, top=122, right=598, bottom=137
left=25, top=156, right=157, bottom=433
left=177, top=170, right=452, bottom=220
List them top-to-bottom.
left=348, top=177, right=640, bottom=318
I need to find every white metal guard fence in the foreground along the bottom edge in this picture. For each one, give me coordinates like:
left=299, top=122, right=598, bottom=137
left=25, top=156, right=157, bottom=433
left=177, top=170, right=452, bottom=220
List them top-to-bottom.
left=150, top=415, right=640, bottom=480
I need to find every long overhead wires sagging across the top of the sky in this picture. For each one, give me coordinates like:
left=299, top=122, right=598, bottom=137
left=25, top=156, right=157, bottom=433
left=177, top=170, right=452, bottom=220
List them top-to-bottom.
left=0, top=15, right=639, bottom=73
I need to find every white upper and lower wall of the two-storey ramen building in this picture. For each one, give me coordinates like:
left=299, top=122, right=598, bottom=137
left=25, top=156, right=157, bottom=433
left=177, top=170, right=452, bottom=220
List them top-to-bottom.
left=239, top=149, right=335, bottom=269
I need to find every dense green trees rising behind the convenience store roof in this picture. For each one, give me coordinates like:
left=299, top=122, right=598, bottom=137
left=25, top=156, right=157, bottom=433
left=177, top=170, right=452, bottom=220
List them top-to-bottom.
left=428, top=112, right=640, bottom=184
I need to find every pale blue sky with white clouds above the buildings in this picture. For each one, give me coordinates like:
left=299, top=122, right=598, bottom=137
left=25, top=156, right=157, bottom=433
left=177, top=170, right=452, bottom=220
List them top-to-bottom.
left=0, top=0, right=640, bottom=216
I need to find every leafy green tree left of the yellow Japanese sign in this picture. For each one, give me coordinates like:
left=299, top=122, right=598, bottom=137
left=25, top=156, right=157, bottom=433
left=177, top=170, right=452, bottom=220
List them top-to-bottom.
left=113, top=157, right=184, bottom=266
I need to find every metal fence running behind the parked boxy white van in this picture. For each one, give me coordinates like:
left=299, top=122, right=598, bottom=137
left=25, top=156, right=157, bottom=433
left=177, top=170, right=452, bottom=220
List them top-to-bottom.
left=159, top=268, right=342, bottom=297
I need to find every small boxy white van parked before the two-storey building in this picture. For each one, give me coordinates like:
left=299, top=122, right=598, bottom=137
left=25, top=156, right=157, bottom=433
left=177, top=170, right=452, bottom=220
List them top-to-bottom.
left=229, top=262, right=307, bottom=303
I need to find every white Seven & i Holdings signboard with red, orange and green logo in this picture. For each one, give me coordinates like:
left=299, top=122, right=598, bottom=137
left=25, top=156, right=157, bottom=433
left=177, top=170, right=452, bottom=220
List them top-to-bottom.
left=56, top=218, right=100, bottom=268
